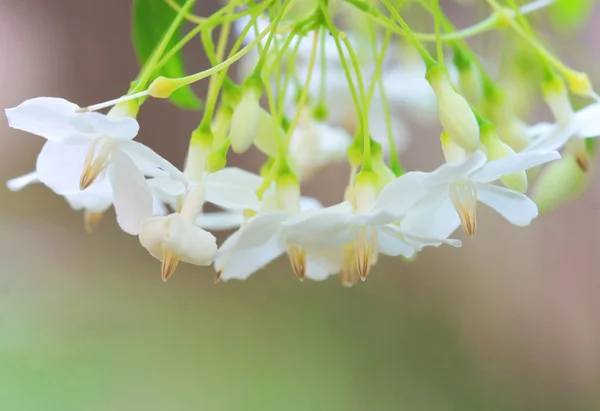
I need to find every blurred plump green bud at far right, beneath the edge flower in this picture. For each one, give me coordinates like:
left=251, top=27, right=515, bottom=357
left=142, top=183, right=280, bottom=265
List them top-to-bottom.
left=531, top=154, right=591, bottom=214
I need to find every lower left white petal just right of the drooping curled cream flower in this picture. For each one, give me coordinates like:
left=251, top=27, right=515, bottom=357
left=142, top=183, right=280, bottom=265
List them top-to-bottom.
left=215, top=233, right=284, bottom=281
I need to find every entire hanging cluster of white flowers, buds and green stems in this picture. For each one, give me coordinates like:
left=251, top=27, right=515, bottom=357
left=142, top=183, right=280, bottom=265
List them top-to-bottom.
left=6, top=0, right=600, bottom=285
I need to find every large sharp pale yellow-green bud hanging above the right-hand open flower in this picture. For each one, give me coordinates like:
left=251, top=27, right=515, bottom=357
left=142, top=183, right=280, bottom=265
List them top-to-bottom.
left=427, top=67, right=479, bottom=152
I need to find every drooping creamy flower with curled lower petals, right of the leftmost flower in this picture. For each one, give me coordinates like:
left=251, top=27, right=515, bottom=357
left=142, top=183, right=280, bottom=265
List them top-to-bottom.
left=140, top=167, right=262, bottom=281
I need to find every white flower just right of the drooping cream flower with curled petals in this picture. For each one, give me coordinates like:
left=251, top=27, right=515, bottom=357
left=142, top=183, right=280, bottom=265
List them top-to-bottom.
left=215, top=182, right=330, bottom=280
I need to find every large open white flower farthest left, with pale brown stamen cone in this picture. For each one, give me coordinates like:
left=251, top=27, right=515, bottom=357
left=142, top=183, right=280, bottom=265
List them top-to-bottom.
left=6, top=97, right=179, bottom=234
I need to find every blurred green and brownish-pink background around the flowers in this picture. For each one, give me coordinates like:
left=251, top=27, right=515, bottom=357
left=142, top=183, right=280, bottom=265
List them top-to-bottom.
left=0, top=0, right=600, bottom=411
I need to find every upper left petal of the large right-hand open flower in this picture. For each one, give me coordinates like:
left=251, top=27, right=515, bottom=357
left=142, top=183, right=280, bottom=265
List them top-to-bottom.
left=371, top=172, right=428, bottom=216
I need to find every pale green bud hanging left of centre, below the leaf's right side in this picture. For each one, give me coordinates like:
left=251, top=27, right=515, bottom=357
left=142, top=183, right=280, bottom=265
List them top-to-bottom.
left=229, top=84, right=261, bottom=153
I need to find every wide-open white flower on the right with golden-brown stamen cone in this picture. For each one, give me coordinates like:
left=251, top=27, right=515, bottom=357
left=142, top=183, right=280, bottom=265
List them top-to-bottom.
left=384, top=151, right=560, bottom=238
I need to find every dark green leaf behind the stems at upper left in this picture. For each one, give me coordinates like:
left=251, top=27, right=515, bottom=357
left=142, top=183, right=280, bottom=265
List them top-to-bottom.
left=133, top=0, right=202, bottom=110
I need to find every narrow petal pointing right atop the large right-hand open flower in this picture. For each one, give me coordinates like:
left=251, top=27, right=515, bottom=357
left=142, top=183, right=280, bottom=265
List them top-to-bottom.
left=471, top=151, right=560, bottom=183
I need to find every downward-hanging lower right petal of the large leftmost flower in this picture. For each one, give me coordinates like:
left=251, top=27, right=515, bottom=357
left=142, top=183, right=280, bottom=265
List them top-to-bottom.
left=108, top=152, right=153, bottom=235
